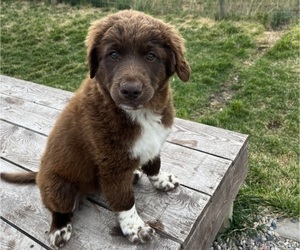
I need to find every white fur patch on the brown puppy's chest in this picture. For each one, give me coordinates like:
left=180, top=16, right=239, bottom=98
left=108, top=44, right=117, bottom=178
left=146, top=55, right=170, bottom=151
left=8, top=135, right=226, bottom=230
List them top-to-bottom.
left=127, top=109, right=171, bottom=165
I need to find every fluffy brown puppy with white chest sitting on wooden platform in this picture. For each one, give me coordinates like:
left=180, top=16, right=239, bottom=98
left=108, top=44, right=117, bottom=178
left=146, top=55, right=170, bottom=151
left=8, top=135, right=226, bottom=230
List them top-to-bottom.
left=1, top=11, right=190, bottom=248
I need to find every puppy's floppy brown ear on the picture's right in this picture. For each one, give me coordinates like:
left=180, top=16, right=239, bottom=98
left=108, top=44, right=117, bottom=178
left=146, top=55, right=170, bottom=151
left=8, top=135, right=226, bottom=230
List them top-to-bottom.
left=167, top=27, right=191, bottom=82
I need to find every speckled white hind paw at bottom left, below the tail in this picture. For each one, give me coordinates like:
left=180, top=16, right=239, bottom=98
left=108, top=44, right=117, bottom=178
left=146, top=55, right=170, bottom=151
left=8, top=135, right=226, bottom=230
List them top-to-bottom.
left=49, top=224, right=72, bottom=249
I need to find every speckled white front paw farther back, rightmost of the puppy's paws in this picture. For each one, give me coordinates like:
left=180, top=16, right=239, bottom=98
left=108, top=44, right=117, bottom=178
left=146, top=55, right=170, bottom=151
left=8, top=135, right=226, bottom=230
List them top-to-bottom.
left=149, top=172, right=179, bottom=191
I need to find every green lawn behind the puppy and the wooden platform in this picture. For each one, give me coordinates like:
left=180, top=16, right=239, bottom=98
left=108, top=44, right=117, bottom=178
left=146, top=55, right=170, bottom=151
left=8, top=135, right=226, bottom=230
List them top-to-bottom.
left=0, top=1, right=300, bottom=237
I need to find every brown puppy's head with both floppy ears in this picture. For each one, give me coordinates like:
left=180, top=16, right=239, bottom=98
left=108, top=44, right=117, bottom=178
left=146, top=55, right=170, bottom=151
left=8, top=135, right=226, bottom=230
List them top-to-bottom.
left=86, top=10, right=190, bottom=110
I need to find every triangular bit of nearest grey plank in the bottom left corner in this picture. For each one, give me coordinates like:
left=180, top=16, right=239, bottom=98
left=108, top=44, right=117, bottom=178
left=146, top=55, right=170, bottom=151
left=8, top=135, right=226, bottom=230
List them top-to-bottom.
left=0, top=220, right=45, bottom=250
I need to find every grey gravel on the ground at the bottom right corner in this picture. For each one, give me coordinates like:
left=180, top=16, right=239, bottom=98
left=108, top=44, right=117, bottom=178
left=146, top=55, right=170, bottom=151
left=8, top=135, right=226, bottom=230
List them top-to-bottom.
left=209, top=216, right=300, bottom=250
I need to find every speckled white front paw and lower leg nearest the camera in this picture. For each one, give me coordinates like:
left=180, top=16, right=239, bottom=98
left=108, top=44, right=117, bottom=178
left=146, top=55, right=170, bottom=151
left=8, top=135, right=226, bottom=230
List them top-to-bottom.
left=118, top=205, right=155, bottom=244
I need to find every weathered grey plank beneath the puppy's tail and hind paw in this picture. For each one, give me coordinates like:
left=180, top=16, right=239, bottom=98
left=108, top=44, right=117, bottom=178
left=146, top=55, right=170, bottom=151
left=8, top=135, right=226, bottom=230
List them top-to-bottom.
left=0, top=159, right=180, bottom=250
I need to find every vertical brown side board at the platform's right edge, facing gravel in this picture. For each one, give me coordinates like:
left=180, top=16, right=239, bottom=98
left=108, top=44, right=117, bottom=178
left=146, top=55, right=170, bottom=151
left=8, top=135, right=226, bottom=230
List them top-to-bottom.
left=182, top=139, right=248, bottom=250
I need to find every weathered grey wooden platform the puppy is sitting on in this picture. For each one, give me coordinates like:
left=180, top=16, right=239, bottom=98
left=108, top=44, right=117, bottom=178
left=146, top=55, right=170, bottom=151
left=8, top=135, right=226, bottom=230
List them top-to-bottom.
left=0, top=76, right=248, bottom=250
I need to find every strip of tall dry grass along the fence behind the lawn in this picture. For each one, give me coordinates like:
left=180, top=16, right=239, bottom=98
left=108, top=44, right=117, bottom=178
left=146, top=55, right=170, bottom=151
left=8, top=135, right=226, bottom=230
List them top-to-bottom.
left=48, top=0, right=299, bottom=27
